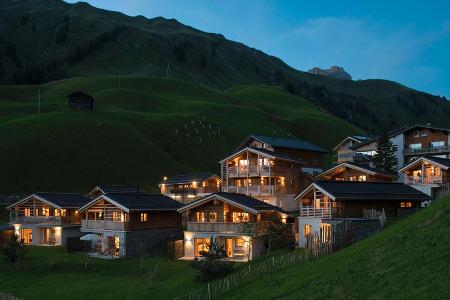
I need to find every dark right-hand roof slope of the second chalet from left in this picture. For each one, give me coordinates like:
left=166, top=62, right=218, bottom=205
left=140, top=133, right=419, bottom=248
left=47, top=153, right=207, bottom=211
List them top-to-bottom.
left=105, top=193, right=183, bottom=211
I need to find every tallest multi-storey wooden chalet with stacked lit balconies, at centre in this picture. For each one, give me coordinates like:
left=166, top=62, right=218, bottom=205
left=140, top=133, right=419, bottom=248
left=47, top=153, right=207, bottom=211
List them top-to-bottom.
left=220, top=135, right=326, bottom=211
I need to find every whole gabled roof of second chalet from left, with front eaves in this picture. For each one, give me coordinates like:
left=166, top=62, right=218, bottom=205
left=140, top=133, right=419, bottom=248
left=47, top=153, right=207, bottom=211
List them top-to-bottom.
left=79, top=193, right=182, bottom=212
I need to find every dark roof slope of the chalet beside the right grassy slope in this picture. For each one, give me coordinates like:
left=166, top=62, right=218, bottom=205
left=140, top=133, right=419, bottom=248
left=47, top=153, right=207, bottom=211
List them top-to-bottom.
left=314, top=180, right=431, bottom=201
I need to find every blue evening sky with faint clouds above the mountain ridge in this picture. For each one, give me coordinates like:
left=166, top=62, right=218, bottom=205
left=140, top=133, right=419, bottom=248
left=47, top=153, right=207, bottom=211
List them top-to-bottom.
left=68, top=0, right=450, bottom=98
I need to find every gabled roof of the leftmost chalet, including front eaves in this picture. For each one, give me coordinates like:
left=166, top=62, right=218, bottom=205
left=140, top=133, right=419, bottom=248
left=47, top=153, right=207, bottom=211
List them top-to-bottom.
left=7, top=193, right=91, bottom=209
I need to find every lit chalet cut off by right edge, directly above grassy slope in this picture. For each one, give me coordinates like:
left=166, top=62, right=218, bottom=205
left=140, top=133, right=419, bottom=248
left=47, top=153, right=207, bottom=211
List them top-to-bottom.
left=399, top=156, right=450, bottom=199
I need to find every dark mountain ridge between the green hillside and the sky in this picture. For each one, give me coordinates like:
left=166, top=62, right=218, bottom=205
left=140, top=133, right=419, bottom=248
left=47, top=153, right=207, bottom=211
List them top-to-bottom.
left=0, top=0, right=450, bottom=133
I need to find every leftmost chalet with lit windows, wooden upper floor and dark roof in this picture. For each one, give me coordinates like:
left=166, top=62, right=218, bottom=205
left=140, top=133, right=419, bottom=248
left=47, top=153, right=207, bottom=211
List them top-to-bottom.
left=7, top=193, right=90, bottom=246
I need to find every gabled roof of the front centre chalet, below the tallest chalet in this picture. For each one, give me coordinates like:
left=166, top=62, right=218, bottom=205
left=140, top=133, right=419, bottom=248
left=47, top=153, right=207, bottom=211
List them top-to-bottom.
left=178, top=192, right=284, bottom=214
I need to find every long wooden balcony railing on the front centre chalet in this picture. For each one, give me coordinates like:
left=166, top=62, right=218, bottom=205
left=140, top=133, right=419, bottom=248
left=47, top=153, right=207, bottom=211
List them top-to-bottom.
left=187, top=222, right=269, bottom=236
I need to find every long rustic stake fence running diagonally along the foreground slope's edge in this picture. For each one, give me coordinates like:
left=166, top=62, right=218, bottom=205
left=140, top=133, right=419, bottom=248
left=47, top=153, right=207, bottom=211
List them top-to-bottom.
left=175, top=251, right=307, bottom=300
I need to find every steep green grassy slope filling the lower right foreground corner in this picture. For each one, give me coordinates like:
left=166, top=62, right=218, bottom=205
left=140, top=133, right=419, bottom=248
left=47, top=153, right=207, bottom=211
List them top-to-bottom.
left=228, top=197, right=450, bottom=299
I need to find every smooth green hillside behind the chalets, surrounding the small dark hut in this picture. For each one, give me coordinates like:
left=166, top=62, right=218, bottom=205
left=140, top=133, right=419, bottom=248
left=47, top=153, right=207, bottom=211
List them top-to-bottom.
left=0, top=77, right=359, bottom=193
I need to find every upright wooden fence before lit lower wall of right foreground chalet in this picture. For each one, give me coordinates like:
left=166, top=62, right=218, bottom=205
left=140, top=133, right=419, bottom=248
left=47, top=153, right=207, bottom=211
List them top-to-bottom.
left=305, top=220, right=353, bottom=258
